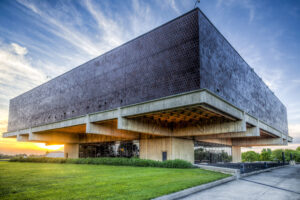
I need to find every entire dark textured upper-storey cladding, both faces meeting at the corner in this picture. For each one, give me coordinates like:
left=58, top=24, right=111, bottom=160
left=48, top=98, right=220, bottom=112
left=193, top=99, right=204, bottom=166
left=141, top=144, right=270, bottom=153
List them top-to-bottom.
left=8, top=9, right=287, bottom=133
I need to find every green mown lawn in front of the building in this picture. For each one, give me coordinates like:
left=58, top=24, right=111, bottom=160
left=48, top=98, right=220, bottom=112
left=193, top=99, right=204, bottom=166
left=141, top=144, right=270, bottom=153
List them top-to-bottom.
left=0, top=161, right=228, bottom=200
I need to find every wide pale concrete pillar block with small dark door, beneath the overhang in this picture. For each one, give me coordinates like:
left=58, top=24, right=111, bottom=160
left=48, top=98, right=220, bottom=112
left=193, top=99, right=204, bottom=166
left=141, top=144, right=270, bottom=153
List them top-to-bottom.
left=140, top=137, right=194, bottom=163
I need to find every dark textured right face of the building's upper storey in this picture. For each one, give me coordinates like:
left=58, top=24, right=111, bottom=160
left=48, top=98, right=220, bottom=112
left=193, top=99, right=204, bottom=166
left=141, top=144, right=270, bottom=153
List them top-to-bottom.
left=199, top=12, right=288, bottom=133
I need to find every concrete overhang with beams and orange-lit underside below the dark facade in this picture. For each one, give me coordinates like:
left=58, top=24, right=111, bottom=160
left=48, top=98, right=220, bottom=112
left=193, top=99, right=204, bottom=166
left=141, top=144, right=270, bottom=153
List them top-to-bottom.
left=3, top=89, right=292, bottom=146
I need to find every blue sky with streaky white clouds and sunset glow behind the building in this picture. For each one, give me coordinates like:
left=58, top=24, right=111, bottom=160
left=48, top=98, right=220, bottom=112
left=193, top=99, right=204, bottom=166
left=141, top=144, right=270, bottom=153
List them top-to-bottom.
left=0, top=0, right=300, bottom=154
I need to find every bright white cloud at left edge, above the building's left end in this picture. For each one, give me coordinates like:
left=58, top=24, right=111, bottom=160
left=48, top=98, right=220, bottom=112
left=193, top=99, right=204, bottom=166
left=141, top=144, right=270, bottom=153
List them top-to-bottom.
left=0, top=43, right=46, bottom=132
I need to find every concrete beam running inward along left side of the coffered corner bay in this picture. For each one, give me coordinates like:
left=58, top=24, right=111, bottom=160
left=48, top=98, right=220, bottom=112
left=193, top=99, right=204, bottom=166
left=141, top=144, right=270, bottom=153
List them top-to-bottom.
left=118, top=117, right=172, bottom=136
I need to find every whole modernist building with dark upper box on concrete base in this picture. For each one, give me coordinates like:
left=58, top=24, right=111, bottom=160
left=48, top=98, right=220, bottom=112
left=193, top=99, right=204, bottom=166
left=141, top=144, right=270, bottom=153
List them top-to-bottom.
left=3, top=9, right=292, bottom=162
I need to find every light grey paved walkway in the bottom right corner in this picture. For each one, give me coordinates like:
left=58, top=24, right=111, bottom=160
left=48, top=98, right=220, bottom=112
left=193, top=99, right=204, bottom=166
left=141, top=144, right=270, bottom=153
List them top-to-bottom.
left=182, top=165, right=300, bottom=200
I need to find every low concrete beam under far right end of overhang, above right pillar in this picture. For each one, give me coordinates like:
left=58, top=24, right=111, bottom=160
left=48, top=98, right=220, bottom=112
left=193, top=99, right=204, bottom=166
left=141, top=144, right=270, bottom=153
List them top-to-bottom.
left=232, top=138, right=287, bottom=147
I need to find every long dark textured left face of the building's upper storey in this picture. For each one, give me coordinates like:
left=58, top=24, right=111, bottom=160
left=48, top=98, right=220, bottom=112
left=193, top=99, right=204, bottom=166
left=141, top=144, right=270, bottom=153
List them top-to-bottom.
left=8, top=10, right=200, bottom=131
